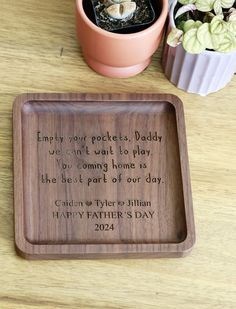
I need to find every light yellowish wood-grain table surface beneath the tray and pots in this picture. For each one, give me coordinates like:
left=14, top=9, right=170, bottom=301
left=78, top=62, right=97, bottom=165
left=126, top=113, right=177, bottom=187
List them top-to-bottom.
left=0, top=0, right=236, bottom=309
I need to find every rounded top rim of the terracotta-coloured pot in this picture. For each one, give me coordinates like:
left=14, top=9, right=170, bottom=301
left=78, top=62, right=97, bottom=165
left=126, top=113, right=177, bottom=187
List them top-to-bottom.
left=76, top=0, right=168, bottom=40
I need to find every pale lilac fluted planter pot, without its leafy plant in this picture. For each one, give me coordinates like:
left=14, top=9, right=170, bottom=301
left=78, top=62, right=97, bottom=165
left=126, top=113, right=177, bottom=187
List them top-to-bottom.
left=162, top=0, right=236, bottom=96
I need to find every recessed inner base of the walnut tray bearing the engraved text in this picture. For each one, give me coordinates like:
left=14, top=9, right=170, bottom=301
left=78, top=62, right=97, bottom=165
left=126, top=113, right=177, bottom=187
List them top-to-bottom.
left=21, top=101, right=186, bottom=244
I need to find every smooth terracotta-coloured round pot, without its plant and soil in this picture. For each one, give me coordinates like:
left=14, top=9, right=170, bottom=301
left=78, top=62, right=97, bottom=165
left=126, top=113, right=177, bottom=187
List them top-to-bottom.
left=76, top=0, right=168, bottom=77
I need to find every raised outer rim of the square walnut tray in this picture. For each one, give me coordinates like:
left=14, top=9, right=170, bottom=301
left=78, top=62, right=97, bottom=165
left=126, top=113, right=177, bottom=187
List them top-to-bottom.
left=13, top=93, right=196, bottom=259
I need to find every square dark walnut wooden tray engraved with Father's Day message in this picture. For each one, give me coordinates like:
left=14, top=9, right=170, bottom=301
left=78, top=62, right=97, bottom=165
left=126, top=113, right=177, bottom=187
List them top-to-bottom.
left=13, top=94, right=195, bottom=259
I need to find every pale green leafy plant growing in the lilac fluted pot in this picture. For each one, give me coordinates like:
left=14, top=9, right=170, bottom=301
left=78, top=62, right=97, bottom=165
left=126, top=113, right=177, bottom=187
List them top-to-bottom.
left=167, top=0, right=236, bottom=54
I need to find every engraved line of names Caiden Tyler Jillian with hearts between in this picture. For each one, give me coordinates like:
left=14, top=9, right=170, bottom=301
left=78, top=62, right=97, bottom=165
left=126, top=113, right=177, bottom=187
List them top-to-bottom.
left=54, top=199, right=152, bottom=208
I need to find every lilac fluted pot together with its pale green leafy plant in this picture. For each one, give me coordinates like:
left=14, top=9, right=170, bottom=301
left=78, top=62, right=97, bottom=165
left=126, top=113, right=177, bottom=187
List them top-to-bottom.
left=162, top=0, right=236, bottom=95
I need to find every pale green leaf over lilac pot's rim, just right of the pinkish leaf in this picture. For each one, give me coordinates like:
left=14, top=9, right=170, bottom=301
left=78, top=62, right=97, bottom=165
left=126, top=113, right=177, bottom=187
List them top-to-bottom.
left=183, top=28, right=206, bottom=54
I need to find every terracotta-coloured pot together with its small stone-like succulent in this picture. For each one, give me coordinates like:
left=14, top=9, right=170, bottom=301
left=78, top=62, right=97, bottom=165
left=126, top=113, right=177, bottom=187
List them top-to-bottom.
left=76, top=0, right=168, bottom=77
